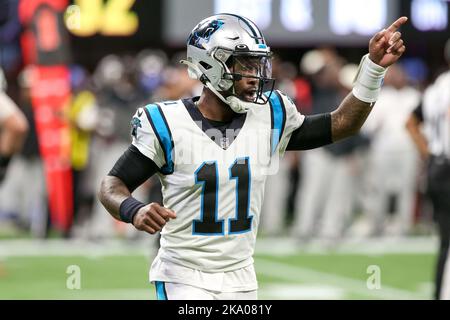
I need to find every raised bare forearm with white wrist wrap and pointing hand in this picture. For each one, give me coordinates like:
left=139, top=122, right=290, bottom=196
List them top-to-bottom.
left=331, top=17, right=408, bottom=142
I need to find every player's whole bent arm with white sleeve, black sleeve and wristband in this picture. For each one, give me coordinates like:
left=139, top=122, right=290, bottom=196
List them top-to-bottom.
left=98, top=109, right=176, bottom=234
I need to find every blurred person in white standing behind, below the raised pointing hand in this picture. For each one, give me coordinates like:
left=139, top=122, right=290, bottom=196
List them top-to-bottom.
left=362, top=64, right=420, bottom=236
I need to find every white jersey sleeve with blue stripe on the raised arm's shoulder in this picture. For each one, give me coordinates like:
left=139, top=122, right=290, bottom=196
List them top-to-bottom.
left=269, top=90, right=305, bottom=156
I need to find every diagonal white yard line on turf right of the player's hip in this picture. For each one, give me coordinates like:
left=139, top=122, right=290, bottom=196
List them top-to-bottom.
left=255, top=258, right=429, bottom=300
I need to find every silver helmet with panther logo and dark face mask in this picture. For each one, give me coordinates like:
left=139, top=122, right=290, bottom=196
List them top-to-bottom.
left=181, top=13, right=275, bottom=112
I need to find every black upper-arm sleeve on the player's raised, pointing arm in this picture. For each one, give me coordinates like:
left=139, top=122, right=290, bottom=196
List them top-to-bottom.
left=286, top=113, right=333, bottom=150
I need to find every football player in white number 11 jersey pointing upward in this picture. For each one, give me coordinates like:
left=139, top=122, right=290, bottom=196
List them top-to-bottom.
left=99, top=14, right=407, bottom=300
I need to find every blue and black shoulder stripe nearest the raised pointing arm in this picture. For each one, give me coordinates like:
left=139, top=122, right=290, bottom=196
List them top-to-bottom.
left=265, top=91, right=286, bottom=154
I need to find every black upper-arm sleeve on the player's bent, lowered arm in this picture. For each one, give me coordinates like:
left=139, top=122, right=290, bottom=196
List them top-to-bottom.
left=108, top=145, right=159, bottom=192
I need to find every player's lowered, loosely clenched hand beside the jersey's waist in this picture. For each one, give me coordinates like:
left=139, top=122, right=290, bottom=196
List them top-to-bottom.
left=133, top=202, right=177, bottom=234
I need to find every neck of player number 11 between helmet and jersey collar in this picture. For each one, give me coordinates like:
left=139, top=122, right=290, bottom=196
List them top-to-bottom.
left=197, top=88, right=236, bottom=122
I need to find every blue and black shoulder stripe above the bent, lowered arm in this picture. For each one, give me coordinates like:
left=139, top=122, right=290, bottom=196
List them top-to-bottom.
left=144, top=104, right=174, bottom=174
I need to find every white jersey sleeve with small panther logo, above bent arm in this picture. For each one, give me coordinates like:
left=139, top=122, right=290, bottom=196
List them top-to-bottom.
left=131, top=108, right=166, bottom=169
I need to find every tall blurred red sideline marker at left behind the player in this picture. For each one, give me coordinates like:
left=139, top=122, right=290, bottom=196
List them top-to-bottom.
left=19, top=0, right=73, bottom=232
